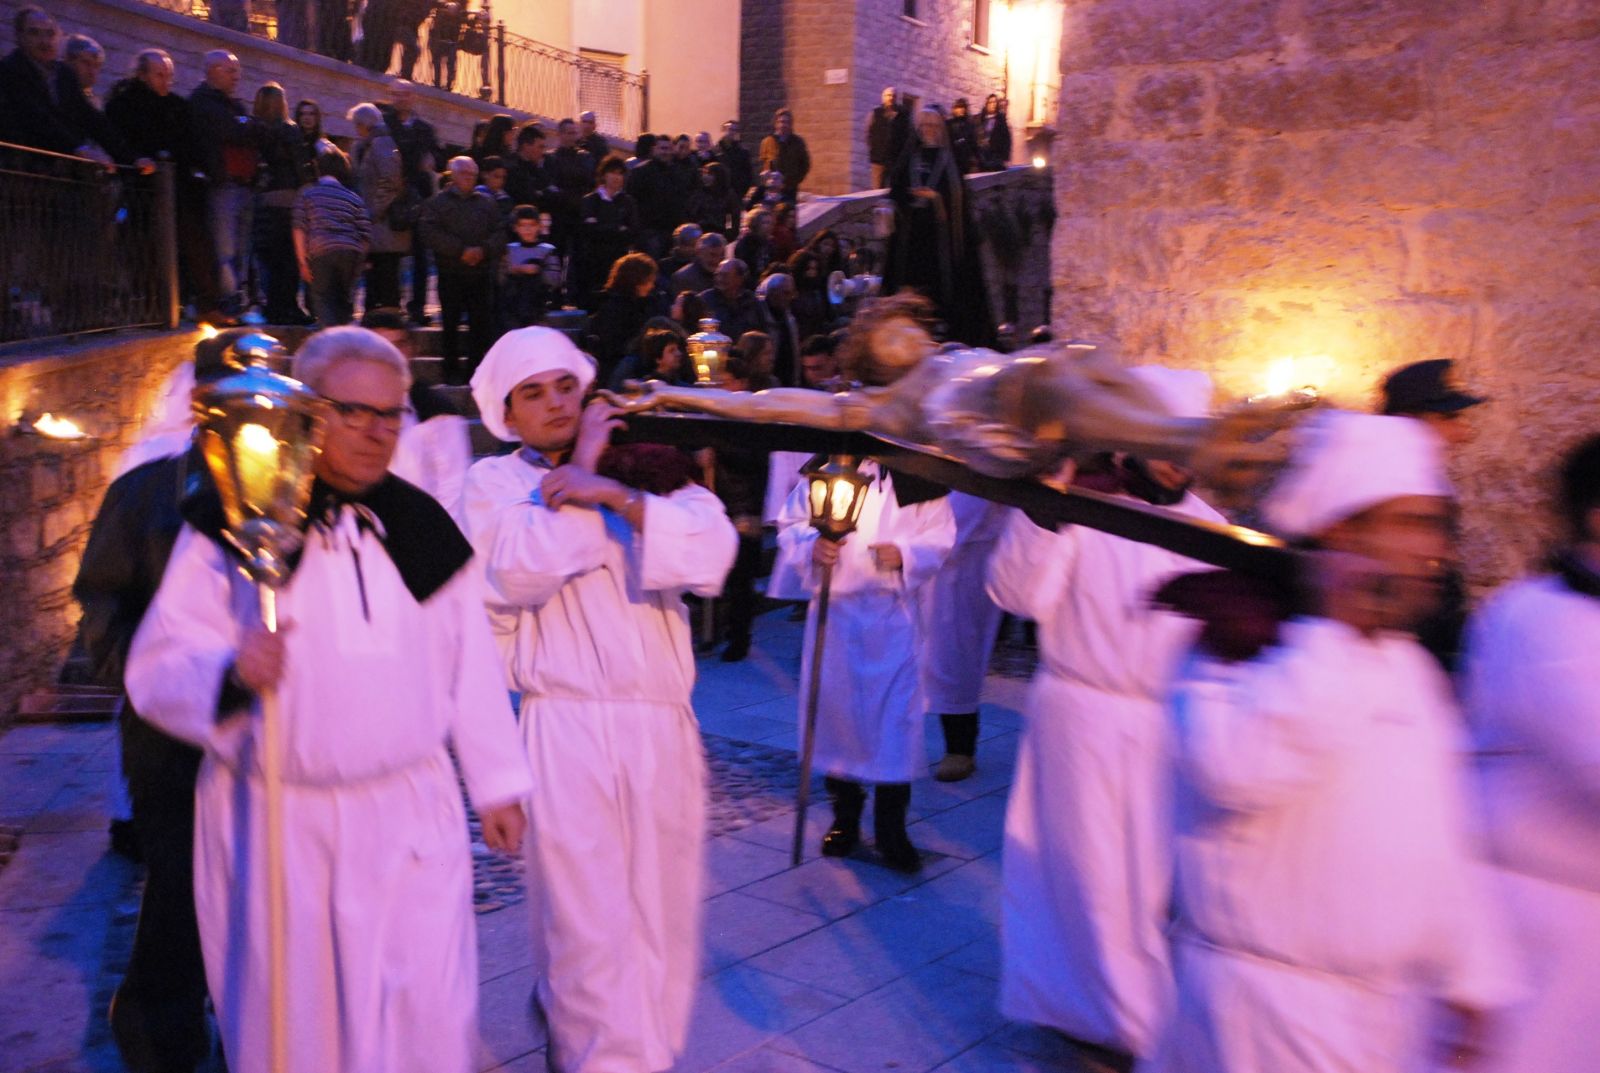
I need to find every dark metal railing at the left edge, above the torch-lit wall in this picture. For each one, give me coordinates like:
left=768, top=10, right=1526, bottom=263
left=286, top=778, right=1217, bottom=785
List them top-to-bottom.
left=0, top=142, right=178, bottom=342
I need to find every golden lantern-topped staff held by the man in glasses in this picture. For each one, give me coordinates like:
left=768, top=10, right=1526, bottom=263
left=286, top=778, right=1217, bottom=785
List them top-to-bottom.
left=195, top=347, right=323, bottom=1073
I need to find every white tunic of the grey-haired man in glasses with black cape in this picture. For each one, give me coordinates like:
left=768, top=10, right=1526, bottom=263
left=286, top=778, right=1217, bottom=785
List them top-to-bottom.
left=126, top=510, right=530, bottom=1073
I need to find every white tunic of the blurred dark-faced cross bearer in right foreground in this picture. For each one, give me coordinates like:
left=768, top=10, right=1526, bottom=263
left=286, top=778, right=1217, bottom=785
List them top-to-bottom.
left=1154, top=619, right=1515, bottom=1073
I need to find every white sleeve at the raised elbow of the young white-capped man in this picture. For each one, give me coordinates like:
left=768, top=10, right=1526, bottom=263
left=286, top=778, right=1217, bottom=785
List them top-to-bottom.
left=635, top=485, right=739, bottom=596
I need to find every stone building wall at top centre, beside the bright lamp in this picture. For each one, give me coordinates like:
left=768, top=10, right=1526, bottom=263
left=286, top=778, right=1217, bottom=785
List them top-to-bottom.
left=739, top=0, right=1002, bottom=193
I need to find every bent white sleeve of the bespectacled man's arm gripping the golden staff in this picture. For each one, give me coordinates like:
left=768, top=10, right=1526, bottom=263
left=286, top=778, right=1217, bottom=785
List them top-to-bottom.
left=125, top=525, right=242, bottom=752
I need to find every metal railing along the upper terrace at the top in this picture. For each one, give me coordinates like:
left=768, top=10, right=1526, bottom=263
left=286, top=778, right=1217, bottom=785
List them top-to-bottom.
left=146, top=0, right=650, bottom=139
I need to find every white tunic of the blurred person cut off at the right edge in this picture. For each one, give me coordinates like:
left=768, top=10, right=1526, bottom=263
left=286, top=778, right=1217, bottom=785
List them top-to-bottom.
left=1467, top=577, right=1600, bottom=1073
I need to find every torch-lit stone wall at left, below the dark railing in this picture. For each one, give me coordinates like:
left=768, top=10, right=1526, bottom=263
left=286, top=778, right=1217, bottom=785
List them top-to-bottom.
left=0, top=333, right=198, bottom=726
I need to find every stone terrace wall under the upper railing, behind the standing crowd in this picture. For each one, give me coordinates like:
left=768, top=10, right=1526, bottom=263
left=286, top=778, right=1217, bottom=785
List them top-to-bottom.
left=0, top=0, right=544, bottom=146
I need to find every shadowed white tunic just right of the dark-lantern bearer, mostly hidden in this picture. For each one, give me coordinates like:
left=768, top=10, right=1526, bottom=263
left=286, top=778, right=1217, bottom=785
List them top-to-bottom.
left=922, top=493, right=1006, bottom=715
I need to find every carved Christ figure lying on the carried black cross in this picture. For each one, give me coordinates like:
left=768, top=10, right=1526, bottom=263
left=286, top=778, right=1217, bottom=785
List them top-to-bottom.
left=603, top=296, right=1283, bottom=483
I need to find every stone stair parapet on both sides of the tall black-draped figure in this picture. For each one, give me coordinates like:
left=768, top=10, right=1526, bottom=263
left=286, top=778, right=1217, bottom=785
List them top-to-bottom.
left=800, top=168, right=1054, bottom=337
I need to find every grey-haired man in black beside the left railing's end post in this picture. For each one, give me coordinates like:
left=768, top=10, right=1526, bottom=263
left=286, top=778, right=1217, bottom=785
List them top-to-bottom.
left=106, top=48, right=224, bottom=323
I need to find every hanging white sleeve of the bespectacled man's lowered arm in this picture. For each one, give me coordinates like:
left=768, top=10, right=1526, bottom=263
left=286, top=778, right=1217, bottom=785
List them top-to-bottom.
left=434, top=569, right=533, bottom=811
